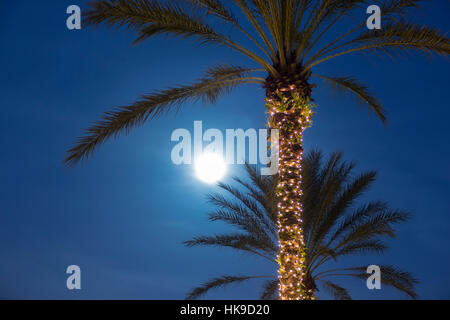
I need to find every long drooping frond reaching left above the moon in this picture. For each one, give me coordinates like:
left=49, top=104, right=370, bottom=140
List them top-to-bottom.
left=64, top=64, right=262, bottom=166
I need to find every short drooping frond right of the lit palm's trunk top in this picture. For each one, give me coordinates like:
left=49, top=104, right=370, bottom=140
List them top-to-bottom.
left=312, top=74, right=387, bottom=123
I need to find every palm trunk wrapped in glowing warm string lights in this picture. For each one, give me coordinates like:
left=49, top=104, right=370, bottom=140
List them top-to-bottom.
left=266, top=79, right=314, bottom=300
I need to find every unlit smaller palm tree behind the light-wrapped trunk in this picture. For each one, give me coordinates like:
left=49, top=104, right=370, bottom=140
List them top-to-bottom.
left=184, top=151, right=417, bottom=299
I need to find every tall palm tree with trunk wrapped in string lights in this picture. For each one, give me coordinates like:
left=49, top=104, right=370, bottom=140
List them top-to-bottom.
left=65, top=0, right=450, bottom=299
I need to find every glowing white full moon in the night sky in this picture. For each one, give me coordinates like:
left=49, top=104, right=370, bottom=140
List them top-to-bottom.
left=195, top=153, right=227, bottom=183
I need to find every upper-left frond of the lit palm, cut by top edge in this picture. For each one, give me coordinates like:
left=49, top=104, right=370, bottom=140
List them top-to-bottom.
left=84, top=0, right=273, bottom=72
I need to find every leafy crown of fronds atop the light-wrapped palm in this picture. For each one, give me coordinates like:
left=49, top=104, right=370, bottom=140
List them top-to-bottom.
left=65, top=0, right=450, bottom=165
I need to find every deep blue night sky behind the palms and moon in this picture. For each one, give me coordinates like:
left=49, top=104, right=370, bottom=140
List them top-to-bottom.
left=0, top=0, right=450, bottom=299
